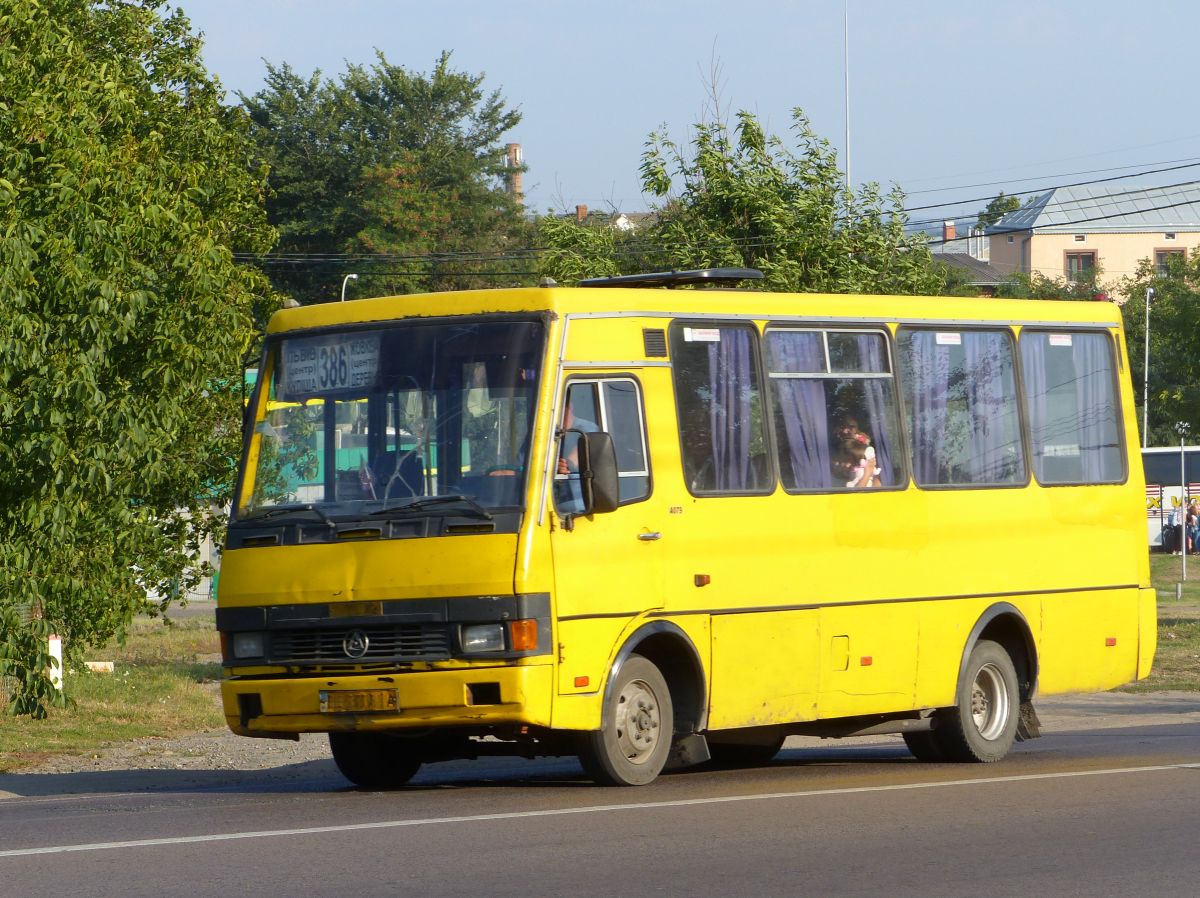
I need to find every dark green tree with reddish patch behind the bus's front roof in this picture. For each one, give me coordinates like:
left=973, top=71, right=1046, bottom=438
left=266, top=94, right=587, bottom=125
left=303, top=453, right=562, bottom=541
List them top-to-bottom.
left=240, top=53, right=528, bottom=303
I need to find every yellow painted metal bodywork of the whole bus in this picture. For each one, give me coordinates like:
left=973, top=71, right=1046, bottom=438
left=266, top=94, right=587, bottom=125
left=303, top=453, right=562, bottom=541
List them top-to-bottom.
left=221, top=288, right=1156, bottom=749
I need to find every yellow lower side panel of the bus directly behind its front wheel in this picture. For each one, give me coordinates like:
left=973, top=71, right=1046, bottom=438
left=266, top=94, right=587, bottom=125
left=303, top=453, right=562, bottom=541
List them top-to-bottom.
left=708, top=610, right=820, bottom=730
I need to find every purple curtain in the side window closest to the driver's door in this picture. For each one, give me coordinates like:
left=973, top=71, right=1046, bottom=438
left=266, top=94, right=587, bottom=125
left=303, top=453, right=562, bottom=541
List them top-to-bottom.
left=708, top=328, right=754, bottom=491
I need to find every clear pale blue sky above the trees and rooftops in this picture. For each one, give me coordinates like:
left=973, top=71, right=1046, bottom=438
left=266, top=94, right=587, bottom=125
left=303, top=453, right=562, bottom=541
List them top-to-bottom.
left=176, top=0, right=1200, bottom=220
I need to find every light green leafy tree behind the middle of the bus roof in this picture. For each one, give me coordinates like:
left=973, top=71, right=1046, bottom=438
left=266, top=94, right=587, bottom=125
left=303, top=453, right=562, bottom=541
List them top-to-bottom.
left=540, top=110, right=943, bottom=293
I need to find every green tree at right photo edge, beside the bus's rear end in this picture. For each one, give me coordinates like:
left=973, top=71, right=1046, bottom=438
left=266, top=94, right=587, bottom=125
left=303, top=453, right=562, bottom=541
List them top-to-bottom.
left=1120, top=247, right=1200, bottom=445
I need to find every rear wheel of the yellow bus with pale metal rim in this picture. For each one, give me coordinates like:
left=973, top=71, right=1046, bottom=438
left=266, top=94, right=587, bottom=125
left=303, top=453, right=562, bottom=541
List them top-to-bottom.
left=932, top=640, right=1021, bottom=764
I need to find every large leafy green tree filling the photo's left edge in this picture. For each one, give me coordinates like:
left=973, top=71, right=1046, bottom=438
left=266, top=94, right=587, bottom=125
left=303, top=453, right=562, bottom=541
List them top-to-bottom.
left=0, top=0, right=274, bottom=714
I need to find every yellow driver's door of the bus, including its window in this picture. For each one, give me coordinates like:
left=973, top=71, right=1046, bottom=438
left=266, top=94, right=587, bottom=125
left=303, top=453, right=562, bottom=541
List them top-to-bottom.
left=551, top=370, right=668, bottom=693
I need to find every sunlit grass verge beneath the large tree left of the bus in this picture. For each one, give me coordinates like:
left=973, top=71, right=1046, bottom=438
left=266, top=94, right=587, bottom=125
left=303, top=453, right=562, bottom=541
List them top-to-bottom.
left=0, top=618, right=224, bottom=773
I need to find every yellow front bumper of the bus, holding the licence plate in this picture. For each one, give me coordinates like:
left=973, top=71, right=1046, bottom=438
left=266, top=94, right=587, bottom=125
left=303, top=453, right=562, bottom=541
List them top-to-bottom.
left=221, top=664, right=554, bottom=737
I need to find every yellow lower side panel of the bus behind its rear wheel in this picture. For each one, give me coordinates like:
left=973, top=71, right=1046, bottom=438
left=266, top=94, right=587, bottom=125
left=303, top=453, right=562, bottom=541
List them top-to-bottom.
left=1039, top=588, right=1140, bottom=694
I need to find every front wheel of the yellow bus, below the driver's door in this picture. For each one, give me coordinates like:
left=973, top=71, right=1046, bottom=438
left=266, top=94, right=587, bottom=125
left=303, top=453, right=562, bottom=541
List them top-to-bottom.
left=580, top=654, right=674, bottom=786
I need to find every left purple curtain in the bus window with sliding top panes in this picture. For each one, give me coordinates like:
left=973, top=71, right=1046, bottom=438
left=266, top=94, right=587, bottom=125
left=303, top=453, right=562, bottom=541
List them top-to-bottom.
left=768, top=331, right=833, bottom=490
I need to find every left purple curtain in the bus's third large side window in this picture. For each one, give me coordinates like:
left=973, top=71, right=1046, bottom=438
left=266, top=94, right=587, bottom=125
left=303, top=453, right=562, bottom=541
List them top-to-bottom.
left=902, top=330, right=950, bottom=484
